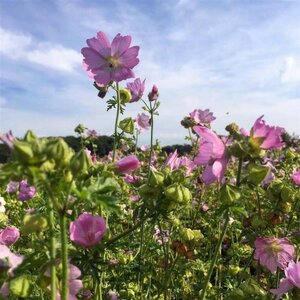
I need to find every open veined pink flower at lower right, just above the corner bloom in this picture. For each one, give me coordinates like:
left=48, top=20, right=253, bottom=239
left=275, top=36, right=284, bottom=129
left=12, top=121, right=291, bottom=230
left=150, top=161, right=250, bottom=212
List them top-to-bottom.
left=254, top=237, right=295, bottom=273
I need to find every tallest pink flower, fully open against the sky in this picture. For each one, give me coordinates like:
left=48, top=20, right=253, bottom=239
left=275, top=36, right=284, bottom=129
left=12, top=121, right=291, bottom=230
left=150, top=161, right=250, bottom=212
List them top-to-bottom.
left=81, top=31, right=139, bottom=86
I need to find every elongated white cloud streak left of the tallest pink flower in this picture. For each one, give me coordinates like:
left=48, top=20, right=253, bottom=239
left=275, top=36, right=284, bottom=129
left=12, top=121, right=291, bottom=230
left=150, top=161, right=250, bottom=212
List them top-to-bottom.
left=0, top=28, right=82, bottom=72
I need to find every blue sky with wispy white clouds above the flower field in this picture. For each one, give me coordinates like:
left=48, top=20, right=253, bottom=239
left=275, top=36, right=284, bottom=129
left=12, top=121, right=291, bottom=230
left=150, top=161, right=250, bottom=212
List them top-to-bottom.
left=0, top=0, right=300, bottom=144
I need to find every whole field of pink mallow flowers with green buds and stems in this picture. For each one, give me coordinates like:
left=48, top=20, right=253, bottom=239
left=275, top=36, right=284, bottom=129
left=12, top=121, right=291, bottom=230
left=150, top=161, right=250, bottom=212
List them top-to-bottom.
left=0, top=31, right=300, bottom=300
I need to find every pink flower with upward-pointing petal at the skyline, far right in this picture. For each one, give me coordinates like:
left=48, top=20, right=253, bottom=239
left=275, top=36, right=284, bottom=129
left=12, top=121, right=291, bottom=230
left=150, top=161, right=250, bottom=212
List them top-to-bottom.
left=250, top=115, right=285, bottom=150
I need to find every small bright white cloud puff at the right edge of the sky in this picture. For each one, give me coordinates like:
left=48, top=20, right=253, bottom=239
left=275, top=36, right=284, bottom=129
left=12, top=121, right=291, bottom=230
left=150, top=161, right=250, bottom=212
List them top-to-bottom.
left=280, top=56, right=300, bottom=83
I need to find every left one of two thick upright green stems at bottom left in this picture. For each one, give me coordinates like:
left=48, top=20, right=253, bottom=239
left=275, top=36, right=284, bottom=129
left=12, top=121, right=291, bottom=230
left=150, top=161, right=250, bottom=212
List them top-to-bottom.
left=48, top=200, right=56, bottom=300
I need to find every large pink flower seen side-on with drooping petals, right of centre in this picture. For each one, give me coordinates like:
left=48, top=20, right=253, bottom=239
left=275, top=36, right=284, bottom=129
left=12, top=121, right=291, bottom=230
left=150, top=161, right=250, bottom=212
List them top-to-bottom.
left=193, top=126, right=227, bottom=185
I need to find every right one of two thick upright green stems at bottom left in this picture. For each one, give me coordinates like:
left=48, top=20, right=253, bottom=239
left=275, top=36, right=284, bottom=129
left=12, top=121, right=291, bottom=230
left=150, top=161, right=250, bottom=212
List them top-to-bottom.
left=59, top=214, right=69, bottom=300
